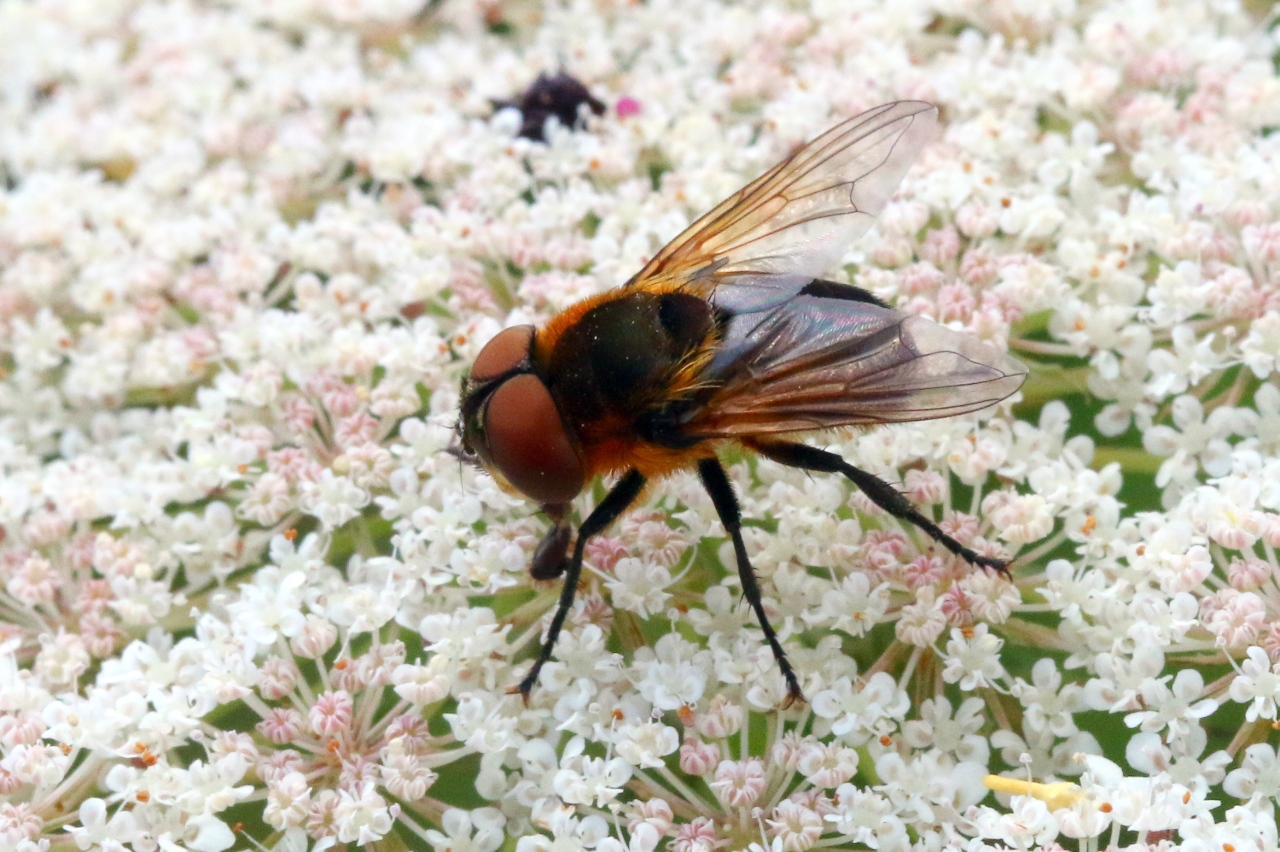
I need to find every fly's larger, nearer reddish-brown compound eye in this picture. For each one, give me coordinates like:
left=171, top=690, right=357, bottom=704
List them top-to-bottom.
left=477, top=373, right=586, bottom=503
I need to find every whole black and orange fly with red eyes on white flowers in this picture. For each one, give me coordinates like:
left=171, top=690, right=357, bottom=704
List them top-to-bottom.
left=458, top=101, right=1027, bottom=704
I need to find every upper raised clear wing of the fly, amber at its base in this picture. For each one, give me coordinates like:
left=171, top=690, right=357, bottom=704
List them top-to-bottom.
left=628, top=101, right=937, bottom=285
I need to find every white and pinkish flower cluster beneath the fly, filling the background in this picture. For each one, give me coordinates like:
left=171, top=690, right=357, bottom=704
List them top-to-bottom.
left=0, top=0, right=1280, bottom=852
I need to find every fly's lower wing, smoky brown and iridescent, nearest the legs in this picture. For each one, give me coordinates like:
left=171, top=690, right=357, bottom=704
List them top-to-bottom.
left=681, top=275, right=1027, bottom=439
